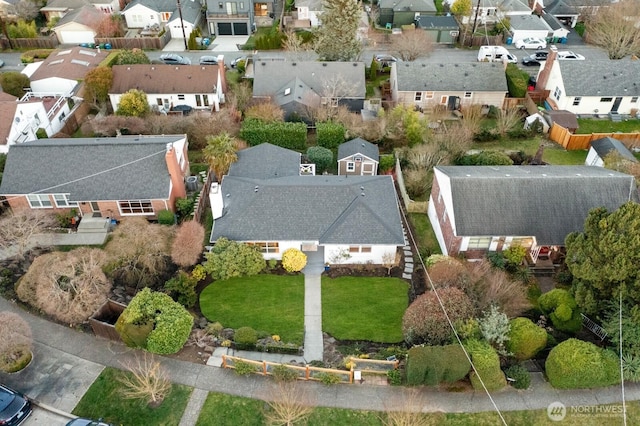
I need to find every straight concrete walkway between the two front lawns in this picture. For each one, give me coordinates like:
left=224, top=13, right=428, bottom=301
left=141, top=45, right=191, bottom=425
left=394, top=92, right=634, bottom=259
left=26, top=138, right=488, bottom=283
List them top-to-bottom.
left=302, top=247, right=324, bottom=362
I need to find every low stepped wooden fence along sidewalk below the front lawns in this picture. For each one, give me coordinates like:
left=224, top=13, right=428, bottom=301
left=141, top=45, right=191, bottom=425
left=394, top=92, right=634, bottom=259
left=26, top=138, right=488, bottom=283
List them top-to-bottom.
left=222, top=355, right=398, bottom=383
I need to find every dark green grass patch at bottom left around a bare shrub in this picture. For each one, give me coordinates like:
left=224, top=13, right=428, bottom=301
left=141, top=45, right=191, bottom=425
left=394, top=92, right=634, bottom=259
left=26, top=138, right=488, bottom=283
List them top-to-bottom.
left=73, top=367, right=192, bottom=426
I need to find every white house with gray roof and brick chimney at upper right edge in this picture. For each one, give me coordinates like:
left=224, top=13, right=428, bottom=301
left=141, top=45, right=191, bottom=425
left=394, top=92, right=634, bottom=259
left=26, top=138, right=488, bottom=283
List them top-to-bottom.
left=536, top=55, right=640, bottom=116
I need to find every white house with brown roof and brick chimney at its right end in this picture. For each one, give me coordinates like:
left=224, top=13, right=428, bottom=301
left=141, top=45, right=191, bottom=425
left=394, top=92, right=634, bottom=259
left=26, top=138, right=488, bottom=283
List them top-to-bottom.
left=109, top=60, right=226, bottom=112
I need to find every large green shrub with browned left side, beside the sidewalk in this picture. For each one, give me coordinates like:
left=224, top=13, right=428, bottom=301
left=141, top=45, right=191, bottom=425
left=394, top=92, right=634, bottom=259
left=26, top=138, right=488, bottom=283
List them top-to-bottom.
left=115, top=287, right=193, bottom=354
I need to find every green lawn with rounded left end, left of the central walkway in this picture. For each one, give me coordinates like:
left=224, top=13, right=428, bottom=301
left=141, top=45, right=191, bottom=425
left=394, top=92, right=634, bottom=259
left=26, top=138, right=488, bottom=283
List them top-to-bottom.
left=200, top=275, right=304, bottom=344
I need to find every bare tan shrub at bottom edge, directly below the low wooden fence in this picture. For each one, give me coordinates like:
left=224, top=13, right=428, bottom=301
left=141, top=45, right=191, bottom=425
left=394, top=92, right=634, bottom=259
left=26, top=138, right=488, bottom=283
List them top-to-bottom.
left=265, top=381, right=314, bottom=426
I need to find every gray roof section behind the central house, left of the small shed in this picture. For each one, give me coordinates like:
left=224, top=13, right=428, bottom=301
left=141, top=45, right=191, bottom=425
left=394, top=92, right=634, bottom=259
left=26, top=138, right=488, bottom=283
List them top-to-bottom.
left=225, top=143, right=301, bottom=179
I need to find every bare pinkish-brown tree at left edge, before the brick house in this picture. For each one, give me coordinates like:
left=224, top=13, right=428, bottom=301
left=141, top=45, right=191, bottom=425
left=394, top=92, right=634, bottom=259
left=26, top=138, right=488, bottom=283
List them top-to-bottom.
left=0, top=209, right=56, bottom=259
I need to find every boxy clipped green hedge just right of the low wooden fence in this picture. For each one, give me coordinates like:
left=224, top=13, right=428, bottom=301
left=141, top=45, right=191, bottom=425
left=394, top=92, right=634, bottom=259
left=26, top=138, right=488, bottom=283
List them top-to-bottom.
left=406, top=345, right=471, bottom=386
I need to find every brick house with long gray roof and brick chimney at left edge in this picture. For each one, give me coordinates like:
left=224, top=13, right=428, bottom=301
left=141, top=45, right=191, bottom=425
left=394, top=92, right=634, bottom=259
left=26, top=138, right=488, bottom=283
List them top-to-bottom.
left=0, top=135, right=189, bottom=219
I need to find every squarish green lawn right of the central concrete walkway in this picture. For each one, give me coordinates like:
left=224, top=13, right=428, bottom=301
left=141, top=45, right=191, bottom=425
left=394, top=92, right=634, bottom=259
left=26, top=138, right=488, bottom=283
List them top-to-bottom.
left=322, top=277, right=409, bottom=343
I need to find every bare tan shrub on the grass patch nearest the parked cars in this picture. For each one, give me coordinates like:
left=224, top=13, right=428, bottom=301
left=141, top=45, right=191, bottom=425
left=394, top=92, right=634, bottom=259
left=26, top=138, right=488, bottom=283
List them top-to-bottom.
left=118, top=354, right=171, bottom=407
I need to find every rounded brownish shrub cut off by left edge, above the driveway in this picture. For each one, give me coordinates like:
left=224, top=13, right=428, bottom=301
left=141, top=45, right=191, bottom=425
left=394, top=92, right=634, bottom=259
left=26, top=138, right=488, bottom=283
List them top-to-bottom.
left=0, top=312, right=33, bottom=373
